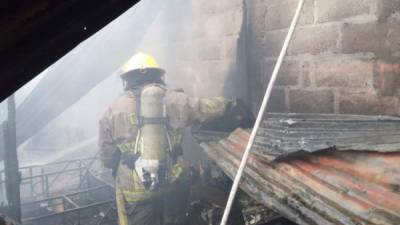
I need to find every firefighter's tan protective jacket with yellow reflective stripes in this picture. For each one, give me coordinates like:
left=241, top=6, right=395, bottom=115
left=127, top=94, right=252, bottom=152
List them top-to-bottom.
left=99, top=86, right=229, bottom=202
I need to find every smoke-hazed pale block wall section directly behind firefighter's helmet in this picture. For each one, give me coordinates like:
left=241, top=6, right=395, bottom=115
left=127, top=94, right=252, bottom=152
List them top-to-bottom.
left=139, top=0, right=247, bottom=98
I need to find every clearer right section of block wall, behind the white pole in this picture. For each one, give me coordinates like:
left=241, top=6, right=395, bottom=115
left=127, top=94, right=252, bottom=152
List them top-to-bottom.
left=246, top=0, right=400, bottom=115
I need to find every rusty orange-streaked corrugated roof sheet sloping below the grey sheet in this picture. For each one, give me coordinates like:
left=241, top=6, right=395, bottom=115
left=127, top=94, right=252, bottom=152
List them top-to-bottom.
left=197, top=118, right=400, bottom=225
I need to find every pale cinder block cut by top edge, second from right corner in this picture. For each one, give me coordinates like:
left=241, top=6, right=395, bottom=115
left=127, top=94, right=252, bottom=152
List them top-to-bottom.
left=315, top=0, right=371, bottom=23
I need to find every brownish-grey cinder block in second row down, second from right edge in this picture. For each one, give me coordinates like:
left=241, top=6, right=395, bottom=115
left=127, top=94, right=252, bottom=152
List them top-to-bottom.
left=342, top=22, right=380, bottom=53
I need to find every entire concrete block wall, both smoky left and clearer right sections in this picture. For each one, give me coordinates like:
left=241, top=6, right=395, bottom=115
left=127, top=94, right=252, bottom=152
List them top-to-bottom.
left=134, top=0, right=400, bottom=115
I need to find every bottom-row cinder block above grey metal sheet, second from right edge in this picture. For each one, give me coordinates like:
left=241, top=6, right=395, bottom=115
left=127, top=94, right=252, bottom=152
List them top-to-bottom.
left=290, top=89, right=334, bottom=113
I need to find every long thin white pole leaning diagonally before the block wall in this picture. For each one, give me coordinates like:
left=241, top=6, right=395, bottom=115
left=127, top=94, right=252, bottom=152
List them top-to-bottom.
left=220, top=0, right=304, bottom=225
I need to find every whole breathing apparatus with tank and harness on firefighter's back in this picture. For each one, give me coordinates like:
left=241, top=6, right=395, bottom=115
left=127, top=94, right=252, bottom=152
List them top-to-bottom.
left=121, top=83, right=173, bottom=191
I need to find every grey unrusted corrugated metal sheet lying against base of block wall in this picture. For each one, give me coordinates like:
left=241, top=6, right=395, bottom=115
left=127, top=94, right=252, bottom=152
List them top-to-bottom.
left=255, top=114, right=400, bottom=159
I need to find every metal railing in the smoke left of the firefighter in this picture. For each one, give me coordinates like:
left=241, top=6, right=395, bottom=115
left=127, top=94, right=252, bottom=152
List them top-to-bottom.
left=0, top=158, right=116, bottom=225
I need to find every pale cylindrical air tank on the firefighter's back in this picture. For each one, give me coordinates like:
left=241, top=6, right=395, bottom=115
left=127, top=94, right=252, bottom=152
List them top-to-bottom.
left=135, top=85, right=170, bottom=190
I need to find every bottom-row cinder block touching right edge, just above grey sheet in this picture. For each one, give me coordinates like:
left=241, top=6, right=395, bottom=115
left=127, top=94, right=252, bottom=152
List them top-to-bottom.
left=339, top=92, right=398, bottom=115
